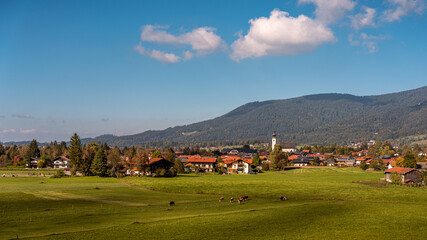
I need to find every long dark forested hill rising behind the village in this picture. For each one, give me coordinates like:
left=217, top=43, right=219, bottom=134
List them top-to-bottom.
left=83, top=86, right=427, bottom=146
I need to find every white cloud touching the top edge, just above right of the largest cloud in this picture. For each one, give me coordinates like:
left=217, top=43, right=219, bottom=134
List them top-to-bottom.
left=298, top=0, right=356, bottom=24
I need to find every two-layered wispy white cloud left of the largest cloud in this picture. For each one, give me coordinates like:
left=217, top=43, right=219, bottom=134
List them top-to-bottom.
left=135, top=25, right=226, bottom=64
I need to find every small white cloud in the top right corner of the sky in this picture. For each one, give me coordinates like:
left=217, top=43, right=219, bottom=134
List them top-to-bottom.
left=383, top=0, right=424, bottom=22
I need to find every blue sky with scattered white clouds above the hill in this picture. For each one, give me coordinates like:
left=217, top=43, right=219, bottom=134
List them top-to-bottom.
left=0, top=0, right=427, bottom=142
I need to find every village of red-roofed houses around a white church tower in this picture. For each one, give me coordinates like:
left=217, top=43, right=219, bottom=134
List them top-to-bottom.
left=8, top=132, right=427, bottom=185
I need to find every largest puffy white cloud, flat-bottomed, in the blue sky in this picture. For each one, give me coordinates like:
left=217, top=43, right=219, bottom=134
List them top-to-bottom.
left=231, top=9, right=336, bottom=61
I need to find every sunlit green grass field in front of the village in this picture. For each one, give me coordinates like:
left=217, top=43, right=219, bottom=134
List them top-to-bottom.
left=0, top=168, right=427, bottom=239
